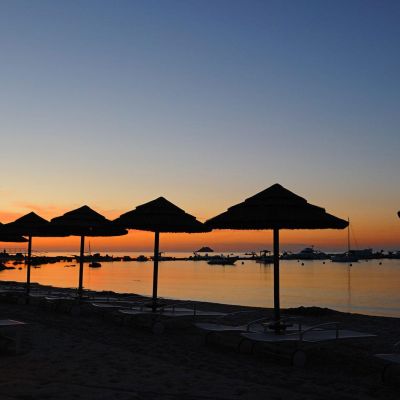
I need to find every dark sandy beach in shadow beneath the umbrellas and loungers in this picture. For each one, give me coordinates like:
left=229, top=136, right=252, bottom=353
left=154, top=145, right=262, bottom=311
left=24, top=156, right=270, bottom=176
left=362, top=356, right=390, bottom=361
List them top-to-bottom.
left=0, top=282, right=400, bottom=399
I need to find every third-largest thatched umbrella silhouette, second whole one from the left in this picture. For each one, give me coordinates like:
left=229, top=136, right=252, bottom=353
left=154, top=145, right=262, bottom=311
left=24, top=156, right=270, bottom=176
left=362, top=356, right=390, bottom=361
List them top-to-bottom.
left=51, top=206, right=128, bottom=297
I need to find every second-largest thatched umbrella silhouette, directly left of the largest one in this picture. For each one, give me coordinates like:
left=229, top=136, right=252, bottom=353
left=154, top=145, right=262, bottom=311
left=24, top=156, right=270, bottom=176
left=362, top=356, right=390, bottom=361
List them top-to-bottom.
left=115, top=197, right=210, bottom=311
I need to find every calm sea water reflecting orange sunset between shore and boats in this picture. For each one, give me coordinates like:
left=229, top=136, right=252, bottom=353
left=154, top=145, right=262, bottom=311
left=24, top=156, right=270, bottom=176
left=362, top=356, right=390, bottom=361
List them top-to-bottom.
left=0, top=253, right=400, bottom=317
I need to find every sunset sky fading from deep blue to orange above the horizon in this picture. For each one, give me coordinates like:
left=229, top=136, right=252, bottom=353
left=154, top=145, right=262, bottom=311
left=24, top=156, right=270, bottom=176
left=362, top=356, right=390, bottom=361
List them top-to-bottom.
left=0, top=0, right=400, bottom=251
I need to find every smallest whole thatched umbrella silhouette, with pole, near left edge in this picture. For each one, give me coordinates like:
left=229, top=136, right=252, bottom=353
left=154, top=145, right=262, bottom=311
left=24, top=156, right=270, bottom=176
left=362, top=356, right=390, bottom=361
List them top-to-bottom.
left=5, top=212, right=67, bottom=302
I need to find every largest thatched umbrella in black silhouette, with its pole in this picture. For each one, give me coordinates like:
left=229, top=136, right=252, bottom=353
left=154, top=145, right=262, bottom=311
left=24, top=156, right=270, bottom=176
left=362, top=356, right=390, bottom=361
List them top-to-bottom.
left=206, top=184, right=348, bottom=331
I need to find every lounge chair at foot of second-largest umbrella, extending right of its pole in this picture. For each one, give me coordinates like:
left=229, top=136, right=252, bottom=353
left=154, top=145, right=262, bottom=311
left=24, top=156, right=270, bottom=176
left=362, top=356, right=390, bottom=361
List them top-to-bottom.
left=119, top=301, right=226, bottom=334
